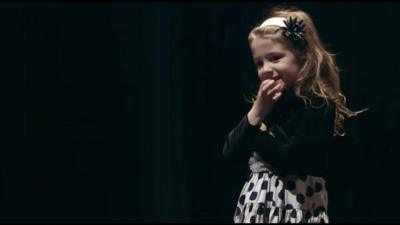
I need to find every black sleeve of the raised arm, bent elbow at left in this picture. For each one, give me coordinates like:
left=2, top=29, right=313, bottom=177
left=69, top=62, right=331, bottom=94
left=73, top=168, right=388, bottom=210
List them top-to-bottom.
left=222, top=114, right=260, bottom=162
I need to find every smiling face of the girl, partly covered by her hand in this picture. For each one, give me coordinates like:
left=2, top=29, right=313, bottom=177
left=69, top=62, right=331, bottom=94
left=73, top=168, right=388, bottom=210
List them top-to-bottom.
left=250, top=37, right=301, bottom=89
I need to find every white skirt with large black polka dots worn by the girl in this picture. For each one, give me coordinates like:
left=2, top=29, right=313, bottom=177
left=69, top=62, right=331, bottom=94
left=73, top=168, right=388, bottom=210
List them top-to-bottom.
left=233, top=153, right=329, bottom=223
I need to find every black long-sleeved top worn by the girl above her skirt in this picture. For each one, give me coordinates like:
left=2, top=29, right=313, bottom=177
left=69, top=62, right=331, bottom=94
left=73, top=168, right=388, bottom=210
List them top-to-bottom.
left=223, top=92, right=335, bottom=177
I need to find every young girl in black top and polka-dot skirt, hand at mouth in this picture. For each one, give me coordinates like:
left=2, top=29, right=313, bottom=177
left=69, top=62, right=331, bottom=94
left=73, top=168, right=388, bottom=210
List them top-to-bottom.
left=223, top=5, right=362, bottom=223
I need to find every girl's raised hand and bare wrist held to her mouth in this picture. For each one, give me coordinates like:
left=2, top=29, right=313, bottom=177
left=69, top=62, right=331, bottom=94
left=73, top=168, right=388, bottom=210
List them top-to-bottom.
left=247, top=79, right=284, bottom=125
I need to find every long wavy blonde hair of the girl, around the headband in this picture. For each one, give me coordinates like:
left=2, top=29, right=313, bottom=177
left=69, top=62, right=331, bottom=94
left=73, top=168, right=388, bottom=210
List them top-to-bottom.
left=248, top=6, right=368, bottom=136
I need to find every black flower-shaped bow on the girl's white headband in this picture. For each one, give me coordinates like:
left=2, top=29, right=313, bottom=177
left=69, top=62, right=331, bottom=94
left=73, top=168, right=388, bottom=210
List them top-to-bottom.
left=283, top=17, right=307, bottom=49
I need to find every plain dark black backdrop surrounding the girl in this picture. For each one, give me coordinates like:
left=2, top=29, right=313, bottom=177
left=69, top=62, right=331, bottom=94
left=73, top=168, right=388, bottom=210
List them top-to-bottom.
left=0, top=2, right=400, bottom=222
